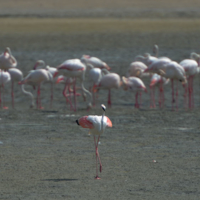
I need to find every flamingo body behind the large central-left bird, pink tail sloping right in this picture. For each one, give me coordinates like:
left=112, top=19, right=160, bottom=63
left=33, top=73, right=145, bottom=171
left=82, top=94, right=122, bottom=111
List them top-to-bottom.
left=81, top=55, right=110, bottom=70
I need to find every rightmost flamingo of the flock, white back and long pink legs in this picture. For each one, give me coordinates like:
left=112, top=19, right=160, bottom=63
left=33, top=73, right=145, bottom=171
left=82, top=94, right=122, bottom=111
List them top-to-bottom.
left=180, top=57, right=200, bottom=109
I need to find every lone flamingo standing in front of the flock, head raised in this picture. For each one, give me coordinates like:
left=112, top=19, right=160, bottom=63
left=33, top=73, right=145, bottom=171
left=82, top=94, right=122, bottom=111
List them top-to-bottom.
left=76, top=104, right=112, bottom=179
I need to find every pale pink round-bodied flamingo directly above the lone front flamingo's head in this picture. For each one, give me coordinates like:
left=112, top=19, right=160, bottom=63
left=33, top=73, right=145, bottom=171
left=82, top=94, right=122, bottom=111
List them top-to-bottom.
left=95, top=73, right=122, bottom=107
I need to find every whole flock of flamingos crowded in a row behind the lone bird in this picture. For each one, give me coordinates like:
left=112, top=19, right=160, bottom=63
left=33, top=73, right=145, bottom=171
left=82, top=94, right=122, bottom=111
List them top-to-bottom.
left=0, top=45, right=200, bottom=112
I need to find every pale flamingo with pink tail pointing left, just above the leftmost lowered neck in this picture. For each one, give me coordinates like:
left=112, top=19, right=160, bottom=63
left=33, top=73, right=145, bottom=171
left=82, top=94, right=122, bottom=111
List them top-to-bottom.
left=18, top=69, right=52, bottom=109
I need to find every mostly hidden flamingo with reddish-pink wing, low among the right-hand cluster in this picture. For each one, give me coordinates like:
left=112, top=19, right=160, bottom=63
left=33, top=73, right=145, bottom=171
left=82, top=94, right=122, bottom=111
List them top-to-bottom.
left=150, top=74, right=169, bottom=108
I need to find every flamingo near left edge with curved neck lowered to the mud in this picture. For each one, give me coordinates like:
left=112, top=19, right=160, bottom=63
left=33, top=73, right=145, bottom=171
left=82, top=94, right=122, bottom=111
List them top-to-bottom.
left=8, top=68, right=34, bottom=108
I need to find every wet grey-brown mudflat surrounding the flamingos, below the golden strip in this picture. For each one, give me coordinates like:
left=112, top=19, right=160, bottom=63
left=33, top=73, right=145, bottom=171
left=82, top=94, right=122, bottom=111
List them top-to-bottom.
left=0, top=16, right=200, bottom=200
